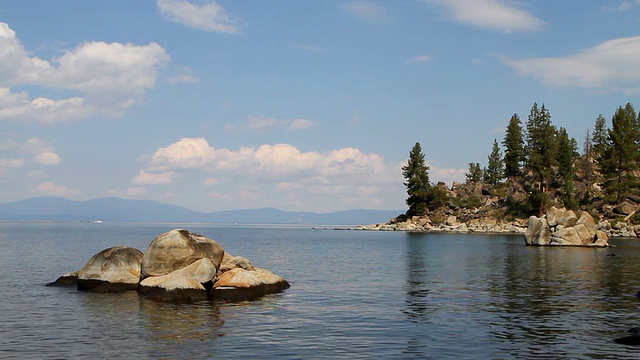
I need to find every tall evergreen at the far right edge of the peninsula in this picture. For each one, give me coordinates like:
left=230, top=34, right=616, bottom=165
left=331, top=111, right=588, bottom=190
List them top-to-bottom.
left=601, top=104, right=639, bottom=202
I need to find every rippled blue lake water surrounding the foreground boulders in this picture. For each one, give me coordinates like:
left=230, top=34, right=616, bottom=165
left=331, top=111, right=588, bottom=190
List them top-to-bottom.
left=0, top=222, right=640, bottom=359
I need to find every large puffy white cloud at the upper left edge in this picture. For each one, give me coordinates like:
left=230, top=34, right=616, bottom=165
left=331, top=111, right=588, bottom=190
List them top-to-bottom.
left=0, top=22, right=169, bottom=123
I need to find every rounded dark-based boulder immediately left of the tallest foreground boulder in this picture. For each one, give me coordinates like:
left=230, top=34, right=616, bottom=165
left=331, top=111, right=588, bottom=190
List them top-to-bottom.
left=78, top=246, right=142, bottom=292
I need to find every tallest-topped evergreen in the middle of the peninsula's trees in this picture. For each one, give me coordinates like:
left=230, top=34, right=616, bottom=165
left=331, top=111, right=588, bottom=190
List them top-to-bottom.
left=525, top=103, right=557, bottom=194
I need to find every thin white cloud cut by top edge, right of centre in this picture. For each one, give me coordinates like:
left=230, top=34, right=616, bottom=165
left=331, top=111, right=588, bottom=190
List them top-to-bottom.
left=424, top=0, right=545, bottom=32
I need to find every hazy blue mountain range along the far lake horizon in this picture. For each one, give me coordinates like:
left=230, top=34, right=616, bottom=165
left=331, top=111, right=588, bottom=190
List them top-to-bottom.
left=0, top=197, right=404, bottom=225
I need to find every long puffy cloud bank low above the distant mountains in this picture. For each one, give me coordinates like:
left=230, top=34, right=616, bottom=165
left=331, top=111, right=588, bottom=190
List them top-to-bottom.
left=134, top=138, right=402, bottom=208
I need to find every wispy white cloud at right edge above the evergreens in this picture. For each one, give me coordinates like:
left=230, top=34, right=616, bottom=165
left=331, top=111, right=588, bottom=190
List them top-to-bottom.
left=503, top=36, right=640, bottom=93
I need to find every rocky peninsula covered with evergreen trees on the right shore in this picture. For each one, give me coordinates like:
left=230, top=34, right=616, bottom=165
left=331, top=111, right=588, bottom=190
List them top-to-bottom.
left=358, top=103, right=640, bottom=237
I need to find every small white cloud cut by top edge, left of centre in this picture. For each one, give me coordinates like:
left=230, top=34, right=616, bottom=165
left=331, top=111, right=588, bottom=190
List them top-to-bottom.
left=156, top=0, right=240, bottom=34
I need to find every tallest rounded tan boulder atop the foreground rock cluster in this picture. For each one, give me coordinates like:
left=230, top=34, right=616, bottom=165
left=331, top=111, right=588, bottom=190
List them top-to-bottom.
left=140, top=229, right=224, bottom=280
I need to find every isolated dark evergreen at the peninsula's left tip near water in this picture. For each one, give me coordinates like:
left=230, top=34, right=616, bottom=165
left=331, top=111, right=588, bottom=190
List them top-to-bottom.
left=402, top=142, right=432, bottom=216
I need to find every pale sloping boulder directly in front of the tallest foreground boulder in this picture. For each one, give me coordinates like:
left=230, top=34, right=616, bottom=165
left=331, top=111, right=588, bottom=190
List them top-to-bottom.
left=139, top=258, right=217, bottom=301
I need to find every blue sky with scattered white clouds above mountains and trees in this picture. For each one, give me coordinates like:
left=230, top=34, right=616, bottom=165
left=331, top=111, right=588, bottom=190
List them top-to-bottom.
left=0, top=0, right=640, bottom=212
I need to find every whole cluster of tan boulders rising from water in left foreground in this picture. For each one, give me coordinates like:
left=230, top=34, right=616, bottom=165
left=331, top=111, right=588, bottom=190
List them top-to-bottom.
left=49, top=229, right=290, bottom=301
